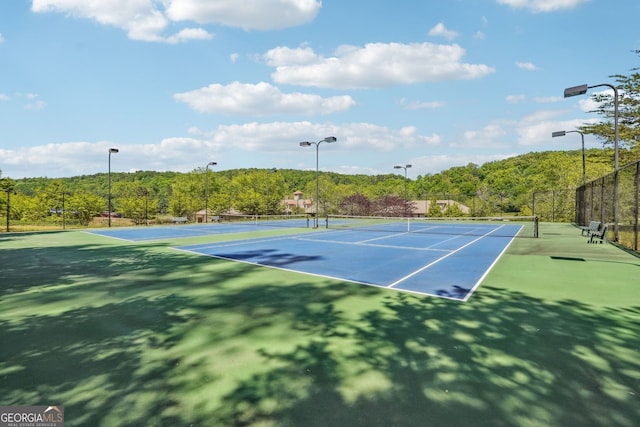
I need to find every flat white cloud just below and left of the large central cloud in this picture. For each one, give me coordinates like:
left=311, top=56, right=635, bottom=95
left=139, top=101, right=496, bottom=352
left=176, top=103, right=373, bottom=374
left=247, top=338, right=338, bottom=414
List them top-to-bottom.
left=173, top=82, right=355, bottom=116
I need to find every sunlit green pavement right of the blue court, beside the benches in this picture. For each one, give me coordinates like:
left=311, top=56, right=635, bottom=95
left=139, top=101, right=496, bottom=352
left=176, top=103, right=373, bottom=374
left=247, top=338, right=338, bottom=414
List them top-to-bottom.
left=481, top=223, right=640, bottom=307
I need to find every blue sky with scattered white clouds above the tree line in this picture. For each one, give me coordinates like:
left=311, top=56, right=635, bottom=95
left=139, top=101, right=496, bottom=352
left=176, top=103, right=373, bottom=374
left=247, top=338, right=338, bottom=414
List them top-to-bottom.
left=0, top=0, right=640, bottom=179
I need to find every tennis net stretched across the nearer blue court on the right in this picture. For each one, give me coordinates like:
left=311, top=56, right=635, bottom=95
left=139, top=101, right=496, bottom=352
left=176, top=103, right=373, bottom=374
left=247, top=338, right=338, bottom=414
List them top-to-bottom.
left=325, top=215, right=538, bottom=238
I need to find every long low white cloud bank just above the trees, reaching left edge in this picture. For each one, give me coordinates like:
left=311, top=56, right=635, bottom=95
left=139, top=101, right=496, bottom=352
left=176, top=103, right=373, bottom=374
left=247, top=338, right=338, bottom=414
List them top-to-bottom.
left=0, top=121, right=440, bottom=179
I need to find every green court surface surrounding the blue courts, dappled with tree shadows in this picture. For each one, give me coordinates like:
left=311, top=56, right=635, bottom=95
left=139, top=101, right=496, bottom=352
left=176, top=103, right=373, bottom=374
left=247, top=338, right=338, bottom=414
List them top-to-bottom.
left=0, top=224, right=640, bottom=427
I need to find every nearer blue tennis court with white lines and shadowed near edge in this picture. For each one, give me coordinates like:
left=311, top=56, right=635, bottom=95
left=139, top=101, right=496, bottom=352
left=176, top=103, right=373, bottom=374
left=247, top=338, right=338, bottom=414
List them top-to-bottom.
left=176, top=225, right=520, bottom=301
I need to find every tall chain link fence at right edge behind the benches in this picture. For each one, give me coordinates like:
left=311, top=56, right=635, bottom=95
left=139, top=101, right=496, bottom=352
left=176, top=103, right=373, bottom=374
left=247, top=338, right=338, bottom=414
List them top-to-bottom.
left=576, top=161, right=640, bottom=251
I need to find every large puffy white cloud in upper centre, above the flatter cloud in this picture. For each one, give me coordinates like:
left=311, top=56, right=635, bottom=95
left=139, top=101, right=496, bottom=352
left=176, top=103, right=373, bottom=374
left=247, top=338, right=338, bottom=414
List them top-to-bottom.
left=264, top=42, right=495, bottom=89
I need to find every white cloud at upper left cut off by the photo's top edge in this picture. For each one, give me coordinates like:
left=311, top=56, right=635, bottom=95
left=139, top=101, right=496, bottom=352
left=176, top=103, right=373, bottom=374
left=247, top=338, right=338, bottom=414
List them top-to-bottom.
left=29, top=0, right=322, bottom=44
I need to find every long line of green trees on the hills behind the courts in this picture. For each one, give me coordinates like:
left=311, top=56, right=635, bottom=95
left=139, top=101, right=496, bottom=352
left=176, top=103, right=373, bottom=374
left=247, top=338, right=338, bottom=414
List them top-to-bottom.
left=0, top=149, right=637, bottom=226
